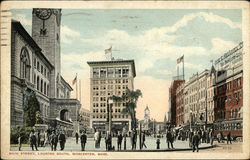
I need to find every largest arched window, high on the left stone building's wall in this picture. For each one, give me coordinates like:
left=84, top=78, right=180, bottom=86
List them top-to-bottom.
left=20, top=47, right=30, bottom=81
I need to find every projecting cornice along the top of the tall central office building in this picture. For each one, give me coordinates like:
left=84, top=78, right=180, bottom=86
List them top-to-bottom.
left=87, top=60, right=136, bottom=77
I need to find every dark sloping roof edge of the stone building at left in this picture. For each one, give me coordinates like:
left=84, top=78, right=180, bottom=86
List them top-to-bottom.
left=11, top=19, right=54, bottom=69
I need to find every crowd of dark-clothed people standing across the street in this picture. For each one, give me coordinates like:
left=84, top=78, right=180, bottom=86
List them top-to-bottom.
left=18, top=128, right=232, bottom=152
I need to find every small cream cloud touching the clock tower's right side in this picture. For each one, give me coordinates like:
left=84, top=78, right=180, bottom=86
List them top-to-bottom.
left=61, top=25, right=80, bottom=44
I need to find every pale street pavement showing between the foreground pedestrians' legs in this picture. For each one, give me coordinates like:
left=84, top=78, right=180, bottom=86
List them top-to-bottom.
left=10, top=137, right=211, bottom=152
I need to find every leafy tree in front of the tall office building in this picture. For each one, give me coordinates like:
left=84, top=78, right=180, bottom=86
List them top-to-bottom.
left=111, top=89, right=142, bottom=130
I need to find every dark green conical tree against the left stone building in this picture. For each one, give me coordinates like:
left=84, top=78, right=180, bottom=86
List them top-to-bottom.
left=24, top=91, right=42, bottom=127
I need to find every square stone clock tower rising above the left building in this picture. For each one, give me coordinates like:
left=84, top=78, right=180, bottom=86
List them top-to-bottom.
left=32, top=8, right=61, bottom=98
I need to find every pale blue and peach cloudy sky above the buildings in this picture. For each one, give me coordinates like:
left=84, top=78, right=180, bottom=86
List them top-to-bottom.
left=12, top=9, right=242, bottom=121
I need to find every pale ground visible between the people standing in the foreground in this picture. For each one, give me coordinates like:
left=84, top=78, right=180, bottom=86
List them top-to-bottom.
left=10, top=137, right=214, bottom=152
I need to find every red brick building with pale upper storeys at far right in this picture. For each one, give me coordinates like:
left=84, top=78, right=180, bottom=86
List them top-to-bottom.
left=214, top=43, right=243, bottom=135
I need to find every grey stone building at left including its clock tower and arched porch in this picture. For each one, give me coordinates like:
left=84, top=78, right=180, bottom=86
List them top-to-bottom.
left=11, top=8, right=81, bottom=132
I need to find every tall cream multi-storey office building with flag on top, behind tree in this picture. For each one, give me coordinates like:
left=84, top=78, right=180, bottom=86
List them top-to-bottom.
left=87, top=60, right=136, bottom=132
